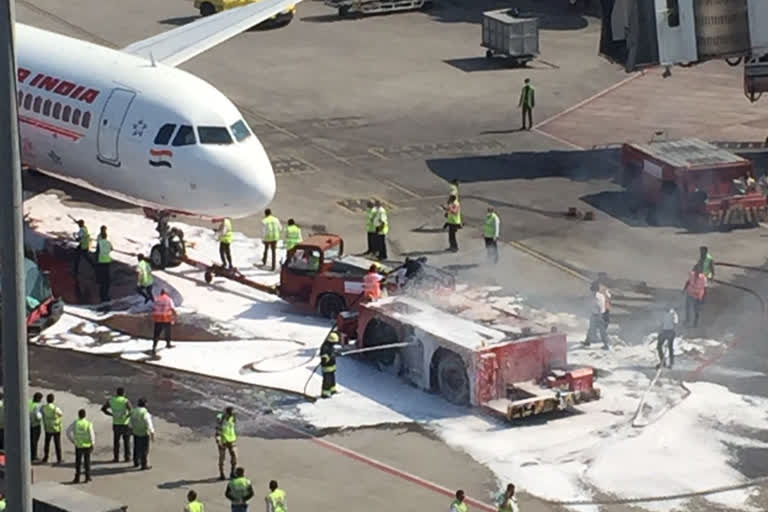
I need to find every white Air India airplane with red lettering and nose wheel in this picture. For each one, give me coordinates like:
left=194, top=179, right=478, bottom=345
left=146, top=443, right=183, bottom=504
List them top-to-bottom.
left=15, top=0, right=300, bottom=268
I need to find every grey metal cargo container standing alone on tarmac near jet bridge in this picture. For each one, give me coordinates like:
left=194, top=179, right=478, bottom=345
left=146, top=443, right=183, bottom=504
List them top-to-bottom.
left=482, top=9, right=539, bottom=63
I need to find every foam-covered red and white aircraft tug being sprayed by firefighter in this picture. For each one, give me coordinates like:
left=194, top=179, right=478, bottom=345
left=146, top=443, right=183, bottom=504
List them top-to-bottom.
left=337, top=296, right=600, bottom=421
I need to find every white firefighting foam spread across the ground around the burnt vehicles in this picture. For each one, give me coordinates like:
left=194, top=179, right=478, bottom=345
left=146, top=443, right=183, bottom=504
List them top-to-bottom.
left=25, top=195, right=768, bottom=511
